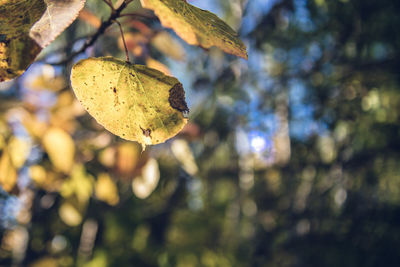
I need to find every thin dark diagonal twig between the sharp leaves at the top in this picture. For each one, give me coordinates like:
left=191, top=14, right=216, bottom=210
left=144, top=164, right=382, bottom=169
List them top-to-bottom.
left=49, top=1, right=129, bottom=65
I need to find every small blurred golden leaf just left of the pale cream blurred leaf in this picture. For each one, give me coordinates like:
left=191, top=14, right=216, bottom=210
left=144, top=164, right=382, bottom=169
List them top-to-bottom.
left=95, top=173, right=119, bottom=206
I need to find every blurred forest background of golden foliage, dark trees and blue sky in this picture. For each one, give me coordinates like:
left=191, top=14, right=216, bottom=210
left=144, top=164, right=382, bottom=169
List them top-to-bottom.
left=0, top=0, right=400, bottom=267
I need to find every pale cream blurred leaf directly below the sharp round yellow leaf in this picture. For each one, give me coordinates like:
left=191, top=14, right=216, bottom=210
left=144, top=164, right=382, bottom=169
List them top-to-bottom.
left=132, top=158, right=160, bottom=199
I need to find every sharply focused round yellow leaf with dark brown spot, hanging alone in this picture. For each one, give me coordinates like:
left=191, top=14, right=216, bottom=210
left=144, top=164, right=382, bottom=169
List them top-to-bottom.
left=71, top=57, right=188, bottom=147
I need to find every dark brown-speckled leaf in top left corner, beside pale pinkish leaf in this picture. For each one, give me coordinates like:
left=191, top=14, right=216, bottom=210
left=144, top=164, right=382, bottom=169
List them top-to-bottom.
left=0, top=0, right=46, bottom=82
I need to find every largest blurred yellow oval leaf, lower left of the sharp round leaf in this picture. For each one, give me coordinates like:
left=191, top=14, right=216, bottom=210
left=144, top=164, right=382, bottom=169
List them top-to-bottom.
left=43, top=127, right=75, bottom=173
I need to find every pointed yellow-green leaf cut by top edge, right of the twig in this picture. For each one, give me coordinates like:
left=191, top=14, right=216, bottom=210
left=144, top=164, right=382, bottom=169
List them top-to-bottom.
left=140, top=0, right=247, bottom=59
